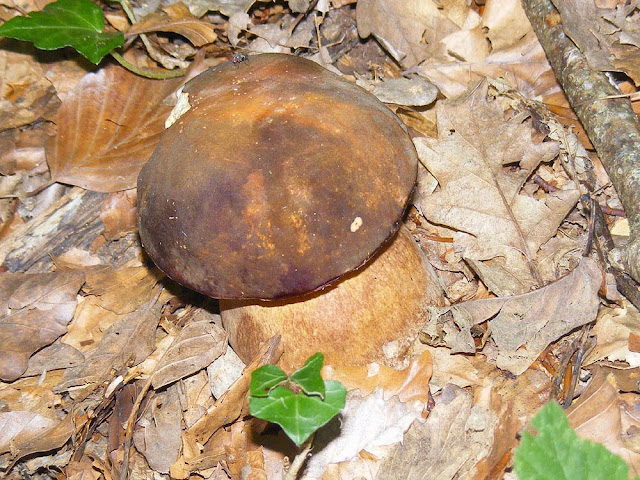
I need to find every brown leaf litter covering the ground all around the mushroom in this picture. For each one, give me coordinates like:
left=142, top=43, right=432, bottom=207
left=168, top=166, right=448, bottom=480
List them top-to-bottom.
left=0, top=0, right=640, bottom=479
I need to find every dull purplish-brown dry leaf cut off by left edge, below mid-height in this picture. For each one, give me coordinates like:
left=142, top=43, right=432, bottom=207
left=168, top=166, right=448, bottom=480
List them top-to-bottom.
left=0, top=271, right=84, bottom=381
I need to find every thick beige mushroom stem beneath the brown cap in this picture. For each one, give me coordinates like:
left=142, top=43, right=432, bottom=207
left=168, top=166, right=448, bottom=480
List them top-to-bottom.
left=220, top=227, right=443, bottom=371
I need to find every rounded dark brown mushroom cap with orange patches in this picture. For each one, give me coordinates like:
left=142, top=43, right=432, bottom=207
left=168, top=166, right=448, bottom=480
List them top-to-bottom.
left=138, top=54, right=417, bottom=299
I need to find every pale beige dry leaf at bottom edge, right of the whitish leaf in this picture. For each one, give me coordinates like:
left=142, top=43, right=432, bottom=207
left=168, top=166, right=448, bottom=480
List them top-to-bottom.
left=378, top=385, right=497, bottom=480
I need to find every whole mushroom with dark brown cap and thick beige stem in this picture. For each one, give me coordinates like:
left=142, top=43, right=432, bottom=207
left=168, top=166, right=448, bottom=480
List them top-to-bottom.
left=138, top=54, right=441, bottom=368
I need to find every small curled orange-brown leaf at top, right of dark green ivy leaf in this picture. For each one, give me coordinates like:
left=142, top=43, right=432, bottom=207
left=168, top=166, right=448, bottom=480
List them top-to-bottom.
left=127, top=2, right=218, bottom=47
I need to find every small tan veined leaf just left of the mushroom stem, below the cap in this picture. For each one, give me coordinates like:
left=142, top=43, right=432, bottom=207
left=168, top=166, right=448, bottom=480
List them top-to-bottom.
left=152, top=309, right=227, bottom=390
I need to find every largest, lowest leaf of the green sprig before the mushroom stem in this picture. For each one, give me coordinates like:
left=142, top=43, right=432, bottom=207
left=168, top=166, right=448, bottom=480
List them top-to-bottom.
left=249, top=380, right=347, bottom=445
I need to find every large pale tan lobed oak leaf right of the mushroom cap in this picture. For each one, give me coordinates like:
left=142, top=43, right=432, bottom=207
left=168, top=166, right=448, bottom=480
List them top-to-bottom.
left=415, top=87, right=580, bottom=295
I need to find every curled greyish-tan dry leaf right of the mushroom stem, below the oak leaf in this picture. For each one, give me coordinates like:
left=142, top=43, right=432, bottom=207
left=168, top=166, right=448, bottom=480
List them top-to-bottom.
left=426, top=258, right=602, bottom=375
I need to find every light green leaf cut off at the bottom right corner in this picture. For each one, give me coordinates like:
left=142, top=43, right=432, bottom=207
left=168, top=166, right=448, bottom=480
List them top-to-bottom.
left=515, top=402, right=638, bottom=480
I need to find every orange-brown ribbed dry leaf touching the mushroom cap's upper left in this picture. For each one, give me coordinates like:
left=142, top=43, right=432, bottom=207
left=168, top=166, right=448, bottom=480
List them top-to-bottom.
left=47, top=65, right=179, bottom=192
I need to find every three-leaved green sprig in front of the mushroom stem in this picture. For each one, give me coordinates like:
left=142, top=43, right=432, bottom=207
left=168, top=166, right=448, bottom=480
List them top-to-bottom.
left=249, top=353, right=347, bottom=446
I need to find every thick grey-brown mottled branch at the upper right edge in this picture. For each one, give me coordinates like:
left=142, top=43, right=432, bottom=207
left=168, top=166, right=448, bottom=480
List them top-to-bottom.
left=522, top=0, right=640, bottom=282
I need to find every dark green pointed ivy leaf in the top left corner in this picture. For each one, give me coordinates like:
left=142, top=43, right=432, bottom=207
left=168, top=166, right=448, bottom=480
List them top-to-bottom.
left=0, top=0, right=124, bottom=65
